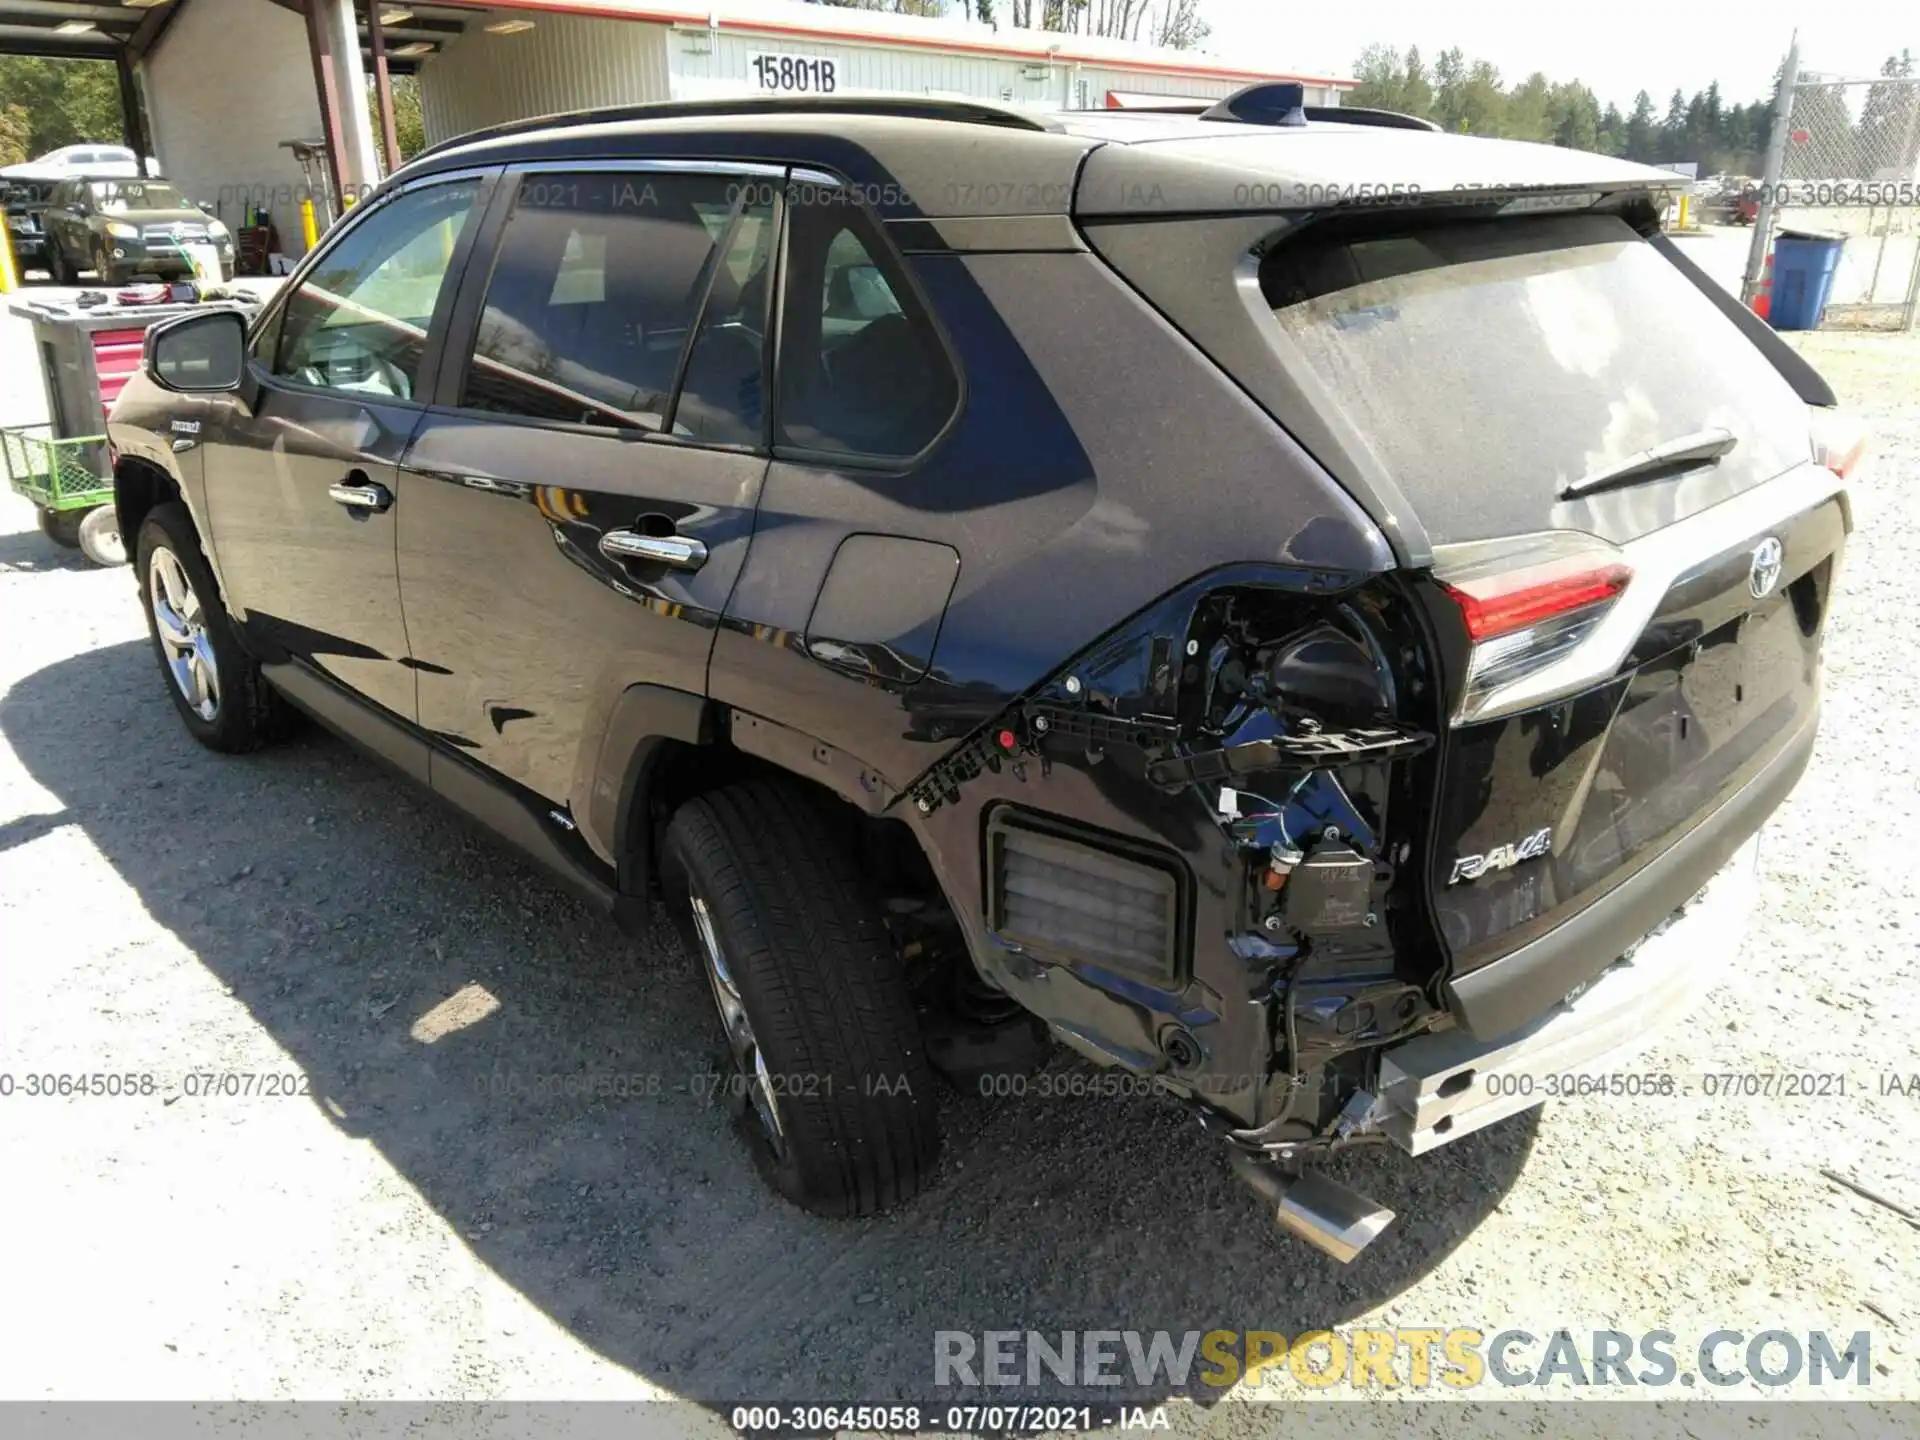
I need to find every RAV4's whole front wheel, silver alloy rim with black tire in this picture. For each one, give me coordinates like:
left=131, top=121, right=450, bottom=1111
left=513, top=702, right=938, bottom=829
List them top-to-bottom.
left=134, top=503, right=292, bottom=755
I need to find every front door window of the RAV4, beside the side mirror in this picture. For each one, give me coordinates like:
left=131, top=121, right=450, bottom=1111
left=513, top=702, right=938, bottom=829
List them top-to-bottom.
left=273, top=180, right=480, bottom=399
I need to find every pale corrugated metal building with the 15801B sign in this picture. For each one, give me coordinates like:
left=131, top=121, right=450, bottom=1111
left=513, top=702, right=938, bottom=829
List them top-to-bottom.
left=420, top=0, right=1354, bottom=142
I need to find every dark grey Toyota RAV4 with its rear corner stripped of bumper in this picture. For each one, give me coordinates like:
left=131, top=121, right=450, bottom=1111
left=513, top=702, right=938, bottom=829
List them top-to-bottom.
left=109, top=86, right=1860, bottom=1260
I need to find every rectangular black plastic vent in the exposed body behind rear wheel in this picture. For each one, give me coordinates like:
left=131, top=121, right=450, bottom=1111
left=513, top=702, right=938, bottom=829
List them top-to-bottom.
left=987, top=812, right=1183, bottom=981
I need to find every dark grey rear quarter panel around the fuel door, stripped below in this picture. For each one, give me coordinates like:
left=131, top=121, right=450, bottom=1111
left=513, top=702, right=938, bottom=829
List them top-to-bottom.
left=710, top=253, right=1392, bottom=1119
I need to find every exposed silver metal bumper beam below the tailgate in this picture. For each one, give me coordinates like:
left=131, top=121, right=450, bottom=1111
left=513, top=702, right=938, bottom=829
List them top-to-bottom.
left=1380, top=835, right=1759, bottom=1154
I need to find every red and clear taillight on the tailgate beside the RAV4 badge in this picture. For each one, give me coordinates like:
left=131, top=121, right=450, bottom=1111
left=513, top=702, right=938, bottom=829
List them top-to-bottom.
left=1438, top=534, right=1634, bottom=724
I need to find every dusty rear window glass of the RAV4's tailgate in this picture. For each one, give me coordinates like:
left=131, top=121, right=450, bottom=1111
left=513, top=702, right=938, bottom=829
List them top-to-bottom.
left=1260, top=215, right=1807, bottom=543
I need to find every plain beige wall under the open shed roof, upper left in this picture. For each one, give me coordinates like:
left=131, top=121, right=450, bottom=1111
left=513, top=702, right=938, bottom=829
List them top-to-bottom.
left=142, top=0, right=321, bottom=255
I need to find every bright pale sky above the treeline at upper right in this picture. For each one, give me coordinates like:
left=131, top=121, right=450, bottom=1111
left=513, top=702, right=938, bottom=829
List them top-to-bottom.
left=1202, top=0, right=1920, bottom=111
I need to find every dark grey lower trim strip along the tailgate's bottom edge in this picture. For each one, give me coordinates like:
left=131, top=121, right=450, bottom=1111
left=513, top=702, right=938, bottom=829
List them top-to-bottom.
left=1446, top=695, right=1818, bottom=1041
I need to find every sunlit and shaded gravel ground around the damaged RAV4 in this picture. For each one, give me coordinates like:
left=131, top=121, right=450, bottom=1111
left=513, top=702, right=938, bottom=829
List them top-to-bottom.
left=0, top=301, right=1920, bottom=1434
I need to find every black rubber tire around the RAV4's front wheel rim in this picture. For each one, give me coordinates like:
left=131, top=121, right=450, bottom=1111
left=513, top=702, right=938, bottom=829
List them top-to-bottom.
left=134, top=501, right=294, bottom=755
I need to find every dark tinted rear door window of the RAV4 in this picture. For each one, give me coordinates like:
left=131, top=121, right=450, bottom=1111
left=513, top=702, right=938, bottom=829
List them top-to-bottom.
left=461, top=171, right=748, bottom=440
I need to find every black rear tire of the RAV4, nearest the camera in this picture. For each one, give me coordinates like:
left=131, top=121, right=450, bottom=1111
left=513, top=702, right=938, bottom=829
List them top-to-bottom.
left=662, top=780, right=939, bottom=1217
